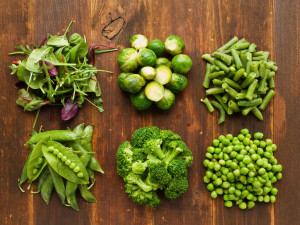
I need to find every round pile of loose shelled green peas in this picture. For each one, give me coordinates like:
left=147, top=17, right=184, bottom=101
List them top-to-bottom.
left=203, top=128, right=282, bottom=209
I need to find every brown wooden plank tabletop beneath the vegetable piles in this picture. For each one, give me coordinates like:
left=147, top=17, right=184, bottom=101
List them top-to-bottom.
left=0, top=0, right=300, bottom=225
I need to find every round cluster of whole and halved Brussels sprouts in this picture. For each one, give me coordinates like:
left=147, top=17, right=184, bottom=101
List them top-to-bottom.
left=118, top=34, right=192, bottom=111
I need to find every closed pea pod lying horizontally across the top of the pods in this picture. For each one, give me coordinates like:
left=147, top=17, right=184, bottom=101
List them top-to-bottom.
left=26, top=130, right=80, bottom=144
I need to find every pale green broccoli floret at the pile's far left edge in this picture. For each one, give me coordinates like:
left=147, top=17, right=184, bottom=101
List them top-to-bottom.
left=116, top=141, right=133, bottom=178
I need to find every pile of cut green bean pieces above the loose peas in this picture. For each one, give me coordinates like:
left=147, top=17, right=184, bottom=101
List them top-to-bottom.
left=200, top=37, right=278, bottom=124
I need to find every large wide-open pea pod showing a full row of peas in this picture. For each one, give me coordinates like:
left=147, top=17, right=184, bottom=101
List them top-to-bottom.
left=42, top=141, right=88, bottom=184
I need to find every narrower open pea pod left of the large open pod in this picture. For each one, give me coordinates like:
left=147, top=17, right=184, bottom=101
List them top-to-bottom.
left=27, top=135, right=49, bottom=182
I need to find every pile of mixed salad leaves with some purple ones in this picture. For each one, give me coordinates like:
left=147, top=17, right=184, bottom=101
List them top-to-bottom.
left=9, top=22, right=117, bottom=120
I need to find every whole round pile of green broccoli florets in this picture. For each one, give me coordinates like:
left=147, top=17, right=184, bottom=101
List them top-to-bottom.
left=116, top=127, right=193, bottom=207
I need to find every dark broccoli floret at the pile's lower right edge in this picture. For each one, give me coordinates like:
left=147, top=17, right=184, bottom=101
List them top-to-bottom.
left=164, top=176, right=189, bottom=199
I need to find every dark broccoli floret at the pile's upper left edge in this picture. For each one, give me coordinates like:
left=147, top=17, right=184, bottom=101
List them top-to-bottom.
left=131, top=127, right=160, bottom=148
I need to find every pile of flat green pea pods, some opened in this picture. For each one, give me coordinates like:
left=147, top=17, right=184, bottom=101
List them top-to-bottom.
left=18, top=124, right=104, bottom=210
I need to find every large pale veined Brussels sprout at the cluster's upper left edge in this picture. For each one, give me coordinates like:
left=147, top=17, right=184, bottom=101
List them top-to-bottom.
left=118, top=48, right=138, bottom=72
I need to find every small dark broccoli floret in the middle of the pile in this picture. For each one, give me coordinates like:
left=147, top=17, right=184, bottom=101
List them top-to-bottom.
left=148, top=162, right=172, bottom=185
